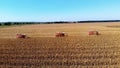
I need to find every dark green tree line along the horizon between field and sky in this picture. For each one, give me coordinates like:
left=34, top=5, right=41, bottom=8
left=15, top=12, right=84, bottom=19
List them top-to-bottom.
left=0, top=20, right=120, bottom=26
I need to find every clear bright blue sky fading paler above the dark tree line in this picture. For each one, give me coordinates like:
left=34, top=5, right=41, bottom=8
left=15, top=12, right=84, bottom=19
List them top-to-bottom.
left=0, top=0, right=120, bottom=22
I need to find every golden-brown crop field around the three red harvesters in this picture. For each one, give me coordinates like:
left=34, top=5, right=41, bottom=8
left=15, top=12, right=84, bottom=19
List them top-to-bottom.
left=0, top=23, right=120, bottom=68
